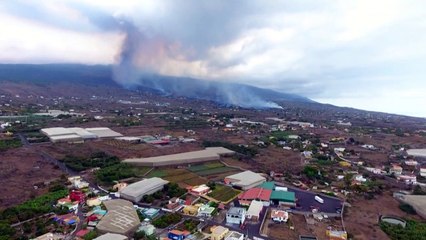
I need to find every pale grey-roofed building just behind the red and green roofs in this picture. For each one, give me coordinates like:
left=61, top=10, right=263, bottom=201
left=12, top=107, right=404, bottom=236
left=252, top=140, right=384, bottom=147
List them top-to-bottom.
left=224, top=171, right=266, bottom=190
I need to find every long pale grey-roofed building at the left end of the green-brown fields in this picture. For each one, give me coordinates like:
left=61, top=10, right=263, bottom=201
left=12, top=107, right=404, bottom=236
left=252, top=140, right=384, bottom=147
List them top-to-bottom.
left=120, top=177, right=169, bottom=202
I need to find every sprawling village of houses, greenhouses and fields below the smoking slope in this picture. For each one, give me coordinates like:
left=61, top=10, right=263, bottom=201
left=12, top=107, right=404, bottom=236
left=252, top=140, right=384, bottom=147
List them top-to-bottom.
left=0, top=90, right=426, bottom=240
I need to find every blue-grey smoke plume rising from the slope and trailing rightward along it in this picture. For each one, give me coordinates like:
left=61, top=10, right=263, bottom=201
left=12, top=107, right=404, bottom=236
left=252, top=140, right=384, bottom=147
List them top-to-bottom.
left=113, top=22, right=281, bottom=108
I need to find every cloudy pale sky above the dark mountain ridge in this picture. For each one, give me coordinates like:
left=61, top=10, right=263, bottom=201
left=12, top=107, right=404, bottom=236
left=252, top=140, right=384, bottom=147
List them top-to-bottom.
left=0, top=0, right=426, bottom=117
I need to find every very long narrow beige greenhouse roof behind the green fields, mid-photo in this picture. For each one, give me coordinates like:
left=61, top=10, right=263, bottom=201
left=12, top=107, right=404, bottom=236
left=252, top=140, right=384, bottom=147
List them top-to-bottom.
left=124, top=147, right=235, bottom=167
